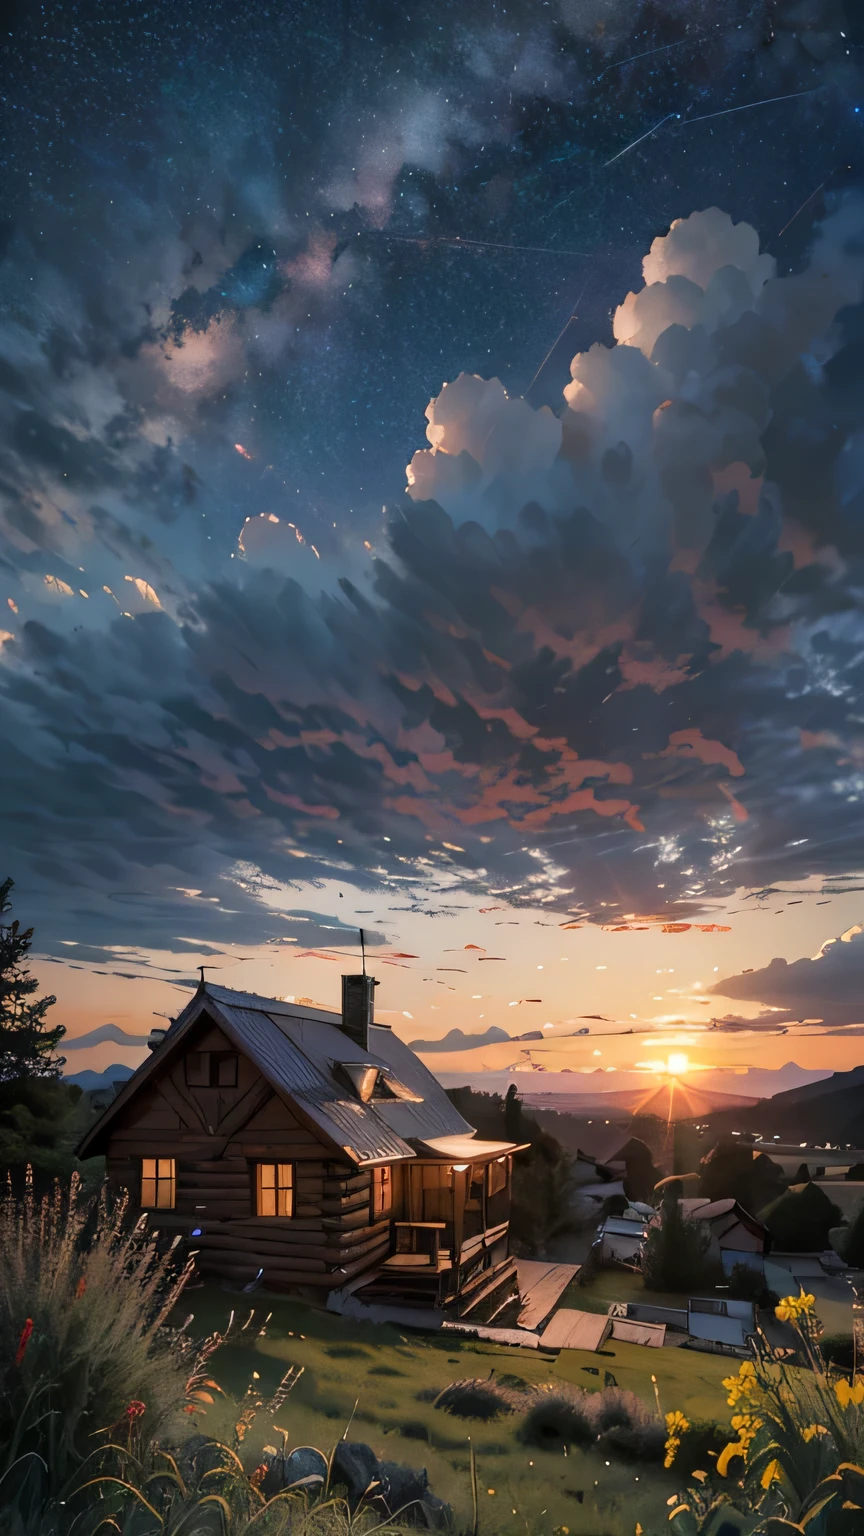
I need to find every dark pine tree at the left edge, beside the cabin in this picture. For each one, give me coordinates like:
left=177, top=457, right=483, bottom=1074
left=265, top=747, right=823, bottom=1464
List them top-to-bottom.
left=0, top=880, right=66, bottom=1083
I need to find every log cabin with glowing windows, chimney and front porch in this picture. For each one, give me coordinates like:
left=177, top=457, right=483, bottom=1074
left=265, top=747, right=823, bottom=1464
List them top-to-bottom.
left=78, top=975, right=520, bottom=1321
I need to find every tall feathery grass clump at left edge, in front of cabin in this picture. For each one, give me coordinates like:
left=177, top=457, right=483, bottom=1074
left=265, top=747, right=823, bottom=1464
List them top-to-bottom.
left=0, top=1175, right=198, bottom=1507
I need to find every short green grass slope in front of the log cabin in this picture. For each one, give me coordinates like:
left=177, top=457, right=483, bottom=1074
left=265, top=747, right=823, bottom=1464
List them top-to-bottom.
left=181, top=1287, right=729, bottom=1536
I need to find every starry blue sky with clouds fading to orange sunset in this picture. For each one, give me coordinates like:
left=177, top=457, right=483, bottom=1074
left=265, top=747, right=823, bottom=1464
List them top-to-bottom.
left=0, top=0, right=864, bottom=1091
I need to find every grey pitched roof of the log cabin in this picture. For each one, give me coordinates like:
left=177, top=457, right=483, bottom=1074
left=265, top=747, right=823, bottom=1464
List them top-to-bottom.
left=78, top=983, right=485, bottom=1164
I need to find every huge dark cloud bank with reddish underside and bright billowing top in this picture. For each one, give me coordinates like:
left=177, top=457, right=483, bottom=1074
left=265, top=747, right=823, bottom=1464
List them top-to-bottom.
left=8, top=195, right=864, bottom=952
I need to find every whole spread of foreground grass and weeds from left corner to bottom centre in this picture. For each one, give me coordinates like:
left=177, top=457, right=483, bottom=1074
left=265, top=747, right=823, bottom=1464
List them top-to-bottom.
left=0, top=1174, right=439, bottom=1536
